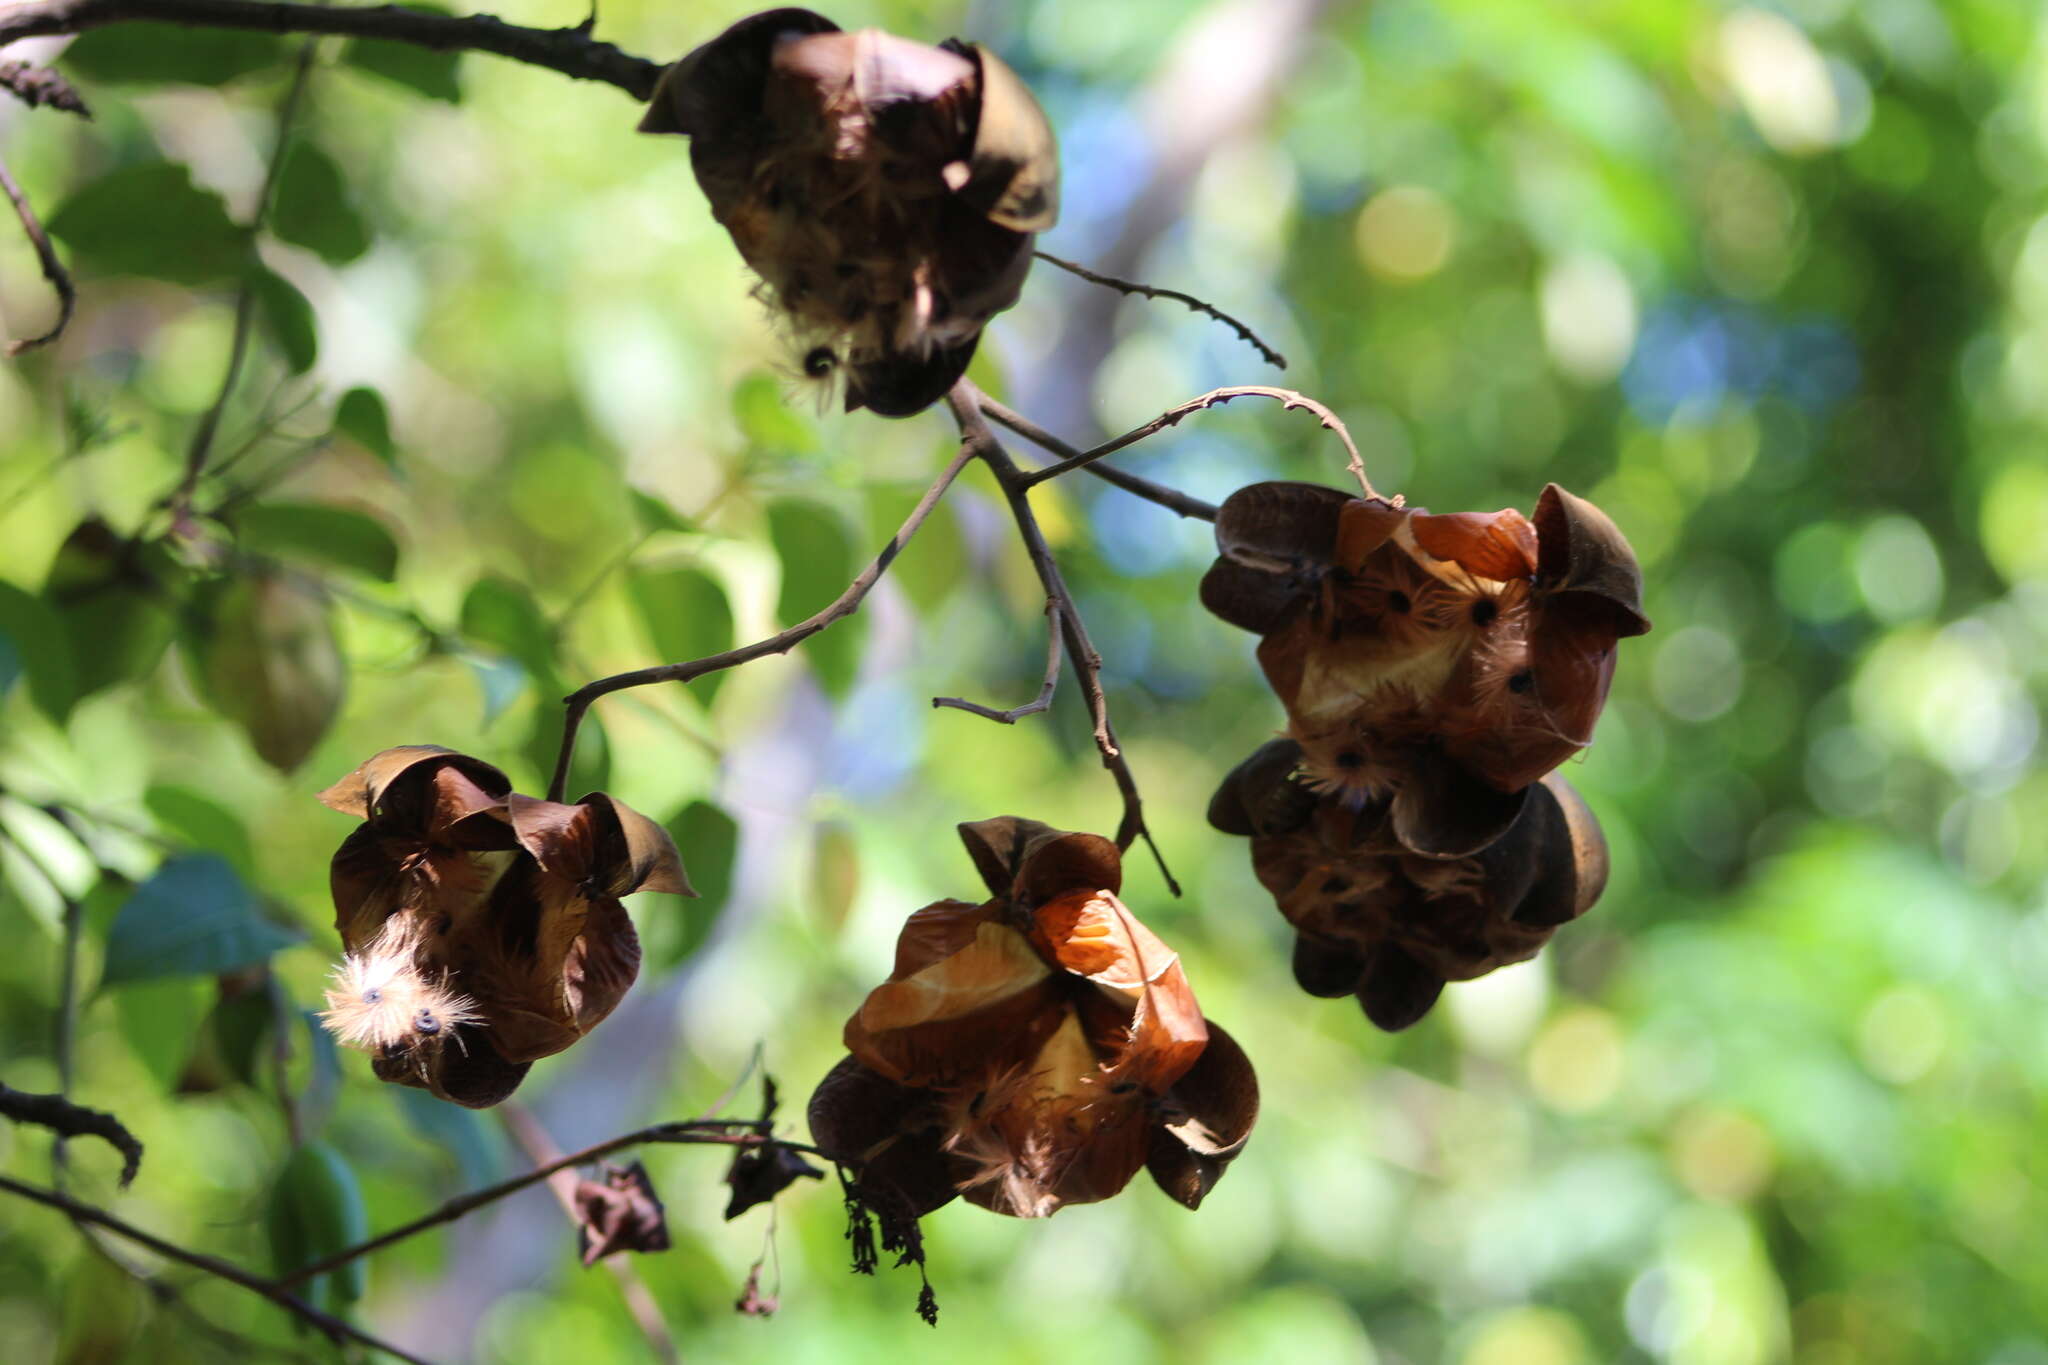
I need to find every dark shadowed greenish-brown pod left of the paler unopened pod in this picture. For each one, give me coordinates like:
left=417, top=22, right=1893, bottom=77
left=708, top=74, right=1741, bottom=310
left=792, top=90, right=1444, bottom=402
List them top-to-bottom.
left=43, top=518, right=176, bottom=700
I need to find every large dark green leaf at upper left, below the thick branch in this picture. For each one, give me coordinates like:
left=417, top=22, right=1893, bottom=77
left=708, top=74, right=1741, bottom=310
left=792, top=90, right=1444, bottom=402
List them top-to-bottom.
left=47, top=162, right=256, bottom=284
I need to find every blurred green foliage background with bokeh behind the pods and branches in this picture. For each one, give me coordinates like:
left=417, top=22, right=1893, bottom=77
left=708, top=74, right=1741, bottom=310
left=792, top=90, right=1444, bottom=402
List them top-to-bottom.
left=0, top=0, right=2048, bottom=1365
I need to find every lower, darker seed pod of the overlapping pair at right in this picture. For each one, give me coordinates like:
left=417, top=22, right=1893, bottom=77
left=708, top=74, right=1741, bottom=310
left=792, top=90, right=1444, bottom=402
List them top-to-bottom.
left=1210, top=741, right=1608, bottom=1029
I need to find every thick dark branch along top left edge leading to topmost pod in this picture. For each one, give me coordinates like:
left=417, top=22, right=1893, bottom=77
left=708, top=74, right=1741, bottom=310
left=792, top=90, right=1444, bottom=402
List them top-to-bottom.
left=0, top=0, right=664, bottom=102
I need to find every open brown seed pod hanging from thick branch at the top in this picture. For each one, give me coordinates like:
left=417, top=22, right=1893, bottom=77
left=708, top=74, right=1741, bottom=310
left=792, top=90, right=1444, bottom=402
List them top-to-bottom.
left=639, top=8, right=1059, bottom=417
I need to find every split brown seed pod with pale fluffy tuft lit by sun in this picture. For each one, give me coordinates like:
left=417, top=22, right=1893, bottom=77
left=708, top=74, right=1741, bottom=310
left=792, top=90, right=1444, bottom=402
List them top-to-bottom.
left=319, top=745, right=692, bottom=1107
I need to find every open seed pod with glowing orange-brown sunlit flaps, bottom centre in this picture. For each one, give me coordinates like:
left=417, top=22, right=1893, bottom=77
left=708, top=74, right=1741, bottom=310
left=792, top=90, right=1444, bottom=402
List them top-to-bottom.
left=811, top=817, right=1257, bottom=1218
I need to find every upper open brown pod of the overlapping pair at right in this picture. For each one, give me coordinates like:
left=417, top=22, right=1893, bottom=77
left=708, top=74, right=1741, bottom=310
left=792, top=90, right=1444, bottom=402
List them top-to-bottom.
left=1202, top=483, right=1649, bottom=802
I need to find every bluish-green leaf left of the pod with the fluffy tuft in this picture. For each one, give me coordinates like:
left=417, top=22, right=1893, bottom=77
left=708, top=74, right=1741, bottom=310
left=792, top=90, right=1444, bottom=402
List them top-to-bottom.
left=100, top=853, right=301, bottom=986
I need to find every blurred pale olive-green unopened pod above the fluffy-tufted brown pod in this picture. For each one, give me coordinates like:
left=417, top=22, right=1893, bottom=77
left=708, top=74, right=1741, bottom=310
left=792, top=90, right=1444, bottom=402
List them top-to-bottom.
left=193, top=573, right=348, bottom=772
